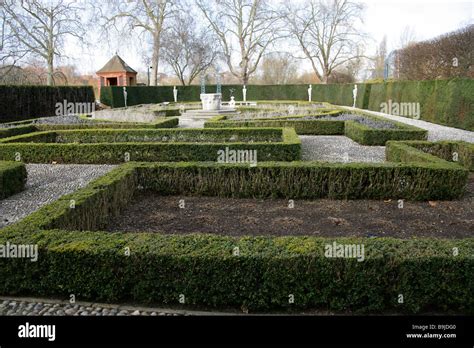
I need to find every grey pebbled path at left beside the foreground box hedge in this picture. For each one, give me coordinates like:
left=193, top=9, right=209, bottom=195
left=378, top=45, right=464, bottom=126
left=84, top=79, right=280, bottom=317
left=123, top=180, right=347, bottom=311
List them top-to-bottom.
left=0, top=164, right=115, bottom=228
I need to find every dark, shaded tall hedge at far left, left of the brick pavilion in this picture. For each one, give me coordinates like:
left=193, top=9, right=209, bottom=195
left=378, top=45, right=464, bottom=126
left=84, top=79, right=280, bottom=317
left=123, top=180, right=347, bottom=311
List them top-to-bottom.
left=0, top=86, right=95, bottom=123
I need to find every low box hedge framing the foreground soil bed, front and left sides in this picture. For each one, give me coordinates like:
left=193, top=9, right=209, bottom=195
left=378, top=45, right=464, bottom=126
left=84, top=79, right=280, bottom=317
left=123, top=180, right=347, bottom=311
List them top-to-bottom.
left=0, top=162, right=474, bottom=314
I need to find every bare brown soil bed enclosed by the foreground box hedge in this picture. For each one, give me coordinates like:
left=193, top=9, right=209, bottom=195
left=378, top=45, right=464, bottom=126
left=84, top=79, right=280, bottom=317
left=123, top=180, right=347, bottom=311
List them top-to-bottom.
left=107, top=176, right=474, bottom=238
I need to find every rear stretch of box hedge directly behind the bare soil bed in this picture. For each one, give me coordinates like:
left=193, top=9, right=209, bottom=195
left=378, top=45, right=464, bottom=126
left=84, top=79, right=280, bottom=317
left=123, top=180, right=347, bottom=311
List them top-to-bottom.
left=133, top=159, right=468, bottom=200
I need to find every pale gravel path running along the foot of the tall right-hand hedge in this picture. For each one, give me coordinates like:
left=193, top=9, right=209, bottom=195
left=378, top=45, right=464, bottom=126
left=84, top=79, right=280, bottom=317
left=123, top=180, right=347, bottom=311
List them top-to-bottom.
left=338, top=106, right=474, bottom=143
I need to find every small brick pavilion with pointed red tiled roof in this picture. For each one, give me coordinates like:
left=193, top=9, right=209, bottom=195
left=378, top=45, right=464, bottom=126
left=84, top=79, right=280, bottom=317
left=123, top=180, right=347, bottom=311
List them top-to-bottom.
left=96, top=54, right=137, bottom=97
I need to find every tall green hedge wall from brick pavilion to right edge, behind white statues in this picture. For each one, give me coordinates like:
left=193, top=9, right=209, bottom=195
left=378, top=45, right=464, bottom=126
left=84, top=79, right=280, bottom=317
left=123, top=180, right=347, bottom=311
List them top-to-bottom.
left=101, top=78, right=474, bottom=131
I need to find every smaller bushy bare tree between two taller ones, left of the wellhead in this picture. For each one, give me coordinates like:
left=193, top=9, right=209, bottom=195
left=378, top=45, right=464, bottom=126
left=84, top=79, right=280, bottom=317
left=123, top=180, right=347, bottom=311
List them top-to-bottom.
left=162, top=15, right=218, bottom=86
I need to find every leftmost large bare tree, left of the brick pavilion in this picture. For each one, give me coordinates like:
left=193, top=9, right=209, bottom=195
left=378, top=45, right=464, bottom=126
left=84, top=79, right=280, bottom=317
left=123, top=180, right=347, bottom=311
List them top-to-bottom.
left=2, top=0, right=84, bottom=85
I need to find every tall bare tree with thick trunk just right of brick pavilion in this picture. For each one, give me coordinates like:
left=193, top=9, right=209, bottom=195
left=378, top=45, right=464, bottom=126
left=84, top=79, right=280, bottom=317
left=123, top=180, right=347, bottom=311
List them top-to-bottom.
left=98, top=0, right=179, bottom=86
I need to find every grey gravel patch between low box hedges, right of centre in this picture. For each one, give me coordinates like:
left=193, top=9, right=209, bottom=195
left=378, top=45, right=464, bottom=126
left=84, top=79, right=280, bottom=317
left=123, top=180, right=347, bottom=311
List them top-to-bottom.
left=300, top=135, right=385, bottom=162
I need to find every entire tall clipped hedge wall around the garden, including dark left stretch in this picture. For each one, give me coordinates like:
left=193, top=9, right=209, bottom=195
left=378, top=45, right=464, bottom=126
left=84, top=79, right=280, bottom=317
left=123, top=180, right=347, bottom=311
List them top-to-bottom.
left=0, top=78, right=474, bottom=131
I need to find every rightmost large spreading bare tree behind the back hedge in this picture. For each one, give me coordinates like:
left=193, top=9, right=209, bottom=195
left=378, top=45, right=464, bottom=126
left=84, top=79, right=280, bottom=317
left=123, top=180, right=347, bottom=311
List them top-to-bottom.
left=282, top=0, right=366, bottom=83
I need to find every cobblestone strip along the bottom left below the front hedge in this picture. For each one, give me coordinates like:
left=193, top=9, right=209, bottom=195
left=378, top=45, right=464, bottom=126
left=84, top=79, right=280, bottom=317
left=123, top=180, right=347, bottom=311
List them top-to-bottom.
left=0, top=300, right=185, bottom=316
